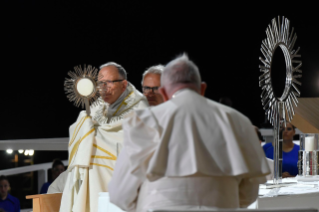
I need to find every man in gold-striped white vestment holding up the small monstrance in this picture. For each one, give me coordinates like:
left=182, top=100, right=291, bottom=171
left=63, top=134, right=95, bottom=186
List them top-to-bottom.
left=48, top=62, right=148, bottom=212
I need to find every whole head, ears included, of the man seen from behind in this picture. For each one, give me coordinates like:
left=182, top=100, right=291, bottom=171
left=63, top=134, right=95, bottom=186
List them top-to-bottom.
left=160, top=54, right=206, bottom=101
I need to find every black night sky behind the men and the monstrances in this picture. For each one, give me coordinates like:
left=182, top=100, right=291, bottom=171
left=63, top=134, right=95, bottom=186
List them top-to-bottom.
left=0, top=0, right=319, bottom=139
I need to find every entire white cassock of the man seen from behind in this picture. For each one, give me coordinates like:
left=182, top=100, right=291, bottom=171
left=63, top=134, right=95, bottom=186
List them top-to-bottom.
left=109, top=89, right=270, bottom=212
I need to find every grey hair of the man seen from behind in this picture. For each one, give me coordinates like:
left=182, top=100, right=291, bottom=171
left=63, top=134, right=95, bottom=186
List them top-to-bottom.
left=161, top=53, right=202, bottom=88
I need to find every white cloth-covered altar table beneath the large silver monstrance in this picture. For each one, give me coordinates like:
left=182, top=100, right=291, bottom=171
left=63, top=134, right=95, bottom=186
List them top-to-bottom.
left=256, top=181, right=319, bottom=209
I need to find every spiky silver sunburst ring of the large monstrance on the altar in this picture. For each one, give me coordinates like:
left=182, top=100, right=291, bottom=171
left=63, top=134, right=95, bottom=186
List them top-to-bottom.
left=259, top=16, right=302, bottom=125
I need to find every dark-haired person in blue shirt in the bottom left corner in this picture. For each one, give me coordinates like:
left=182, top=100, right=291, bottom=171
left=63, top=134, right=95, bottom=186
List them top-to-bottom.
left=0, top=175, right=20, bottom=212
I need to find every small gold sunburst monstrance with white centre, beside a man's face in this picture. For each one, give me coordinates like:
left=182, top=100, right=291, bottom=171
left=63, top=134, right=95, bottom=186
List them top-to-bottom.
left=64, top=65, right=99, bottom=116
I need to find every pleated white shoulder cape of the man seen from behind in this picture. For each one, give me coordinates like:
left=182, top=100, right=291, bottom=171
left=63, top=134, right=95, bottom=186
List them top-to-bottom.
left=124, top=90, right=269, bottom=181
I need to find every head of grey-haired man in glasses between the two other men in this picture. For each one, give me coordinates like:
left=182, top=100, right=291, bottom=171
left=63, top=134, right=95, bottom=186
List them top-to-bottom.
left=142, top=65, right=164, bottom=106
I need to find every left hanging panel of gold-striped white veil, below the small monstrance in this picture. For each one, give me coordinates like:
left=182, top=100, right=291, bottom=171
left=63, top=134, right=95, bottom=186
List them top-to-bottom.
left=60, top=112, right=95, bottom=212
